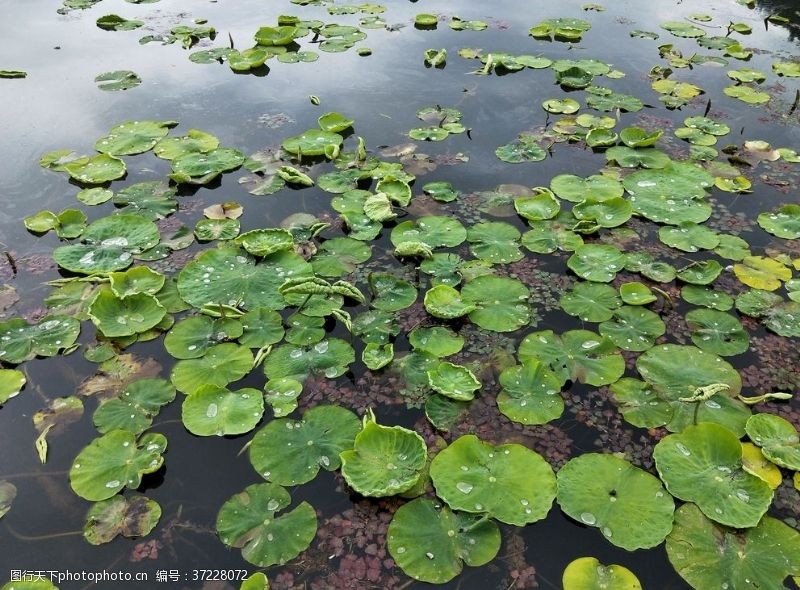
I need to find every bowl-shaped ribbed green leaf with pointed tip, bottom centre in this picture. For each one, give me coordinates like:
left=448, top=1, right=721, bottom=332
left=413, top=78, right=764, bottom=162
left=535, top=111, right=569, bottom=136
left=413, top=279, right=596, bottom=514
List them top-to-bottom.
left=339, top=411, right=428, bottom=497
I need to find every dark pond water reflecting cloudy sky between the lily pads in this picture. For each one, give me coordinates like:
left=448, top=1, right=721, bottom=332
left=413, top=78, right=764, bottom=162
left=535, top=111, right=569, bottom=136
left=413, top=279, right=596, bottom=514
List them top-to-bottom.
left=0, top=0, right=800, bottom=590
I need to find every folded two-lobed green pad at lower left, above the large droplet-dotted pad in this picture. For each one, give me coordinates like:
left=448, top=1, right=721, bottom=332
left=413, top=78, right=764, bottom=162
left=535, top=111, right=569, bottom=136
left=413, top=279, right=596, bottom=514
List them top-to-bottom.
left=92, top=378, right=175, bottom=435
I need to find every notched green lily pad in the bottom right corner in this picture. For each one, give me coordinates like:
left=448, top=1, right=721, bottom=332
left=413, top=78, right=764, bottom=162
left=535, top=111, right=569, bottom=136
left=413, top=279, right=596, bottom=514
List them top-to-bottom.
left=667, top=504, right=800, bottom=590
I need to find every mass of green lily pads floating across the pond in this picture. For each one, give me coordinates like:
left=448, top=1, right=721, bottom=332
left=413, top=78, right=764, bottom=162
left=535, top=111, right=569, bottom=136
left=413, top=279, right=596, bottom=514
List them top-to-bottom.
left=0, top=0, right=800, bottom=588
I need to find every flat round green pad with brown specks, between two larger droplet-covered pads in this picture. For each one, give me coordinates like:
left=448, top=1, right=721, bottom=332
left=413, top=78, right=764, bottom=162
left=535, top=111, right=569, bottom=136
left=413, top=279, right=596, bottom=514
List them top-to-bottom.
left=558, top=453, right=675, bottom=551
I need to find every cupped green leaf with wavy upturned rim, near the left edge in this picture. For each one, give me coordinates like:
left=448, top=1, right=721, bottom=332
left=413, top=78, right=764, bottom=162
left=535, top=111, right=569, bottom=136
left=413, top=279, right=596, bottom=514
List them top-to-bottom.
left=89, top=287, right=167, bottom=338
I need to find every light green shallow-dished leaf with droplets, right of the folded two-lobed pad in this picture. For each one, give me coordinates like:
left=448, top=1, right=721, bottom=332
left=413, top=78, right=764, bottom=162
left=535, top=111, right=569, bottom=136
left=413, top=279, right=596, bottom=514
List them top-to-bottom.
left=181, top=385, right=264, bottom=436
